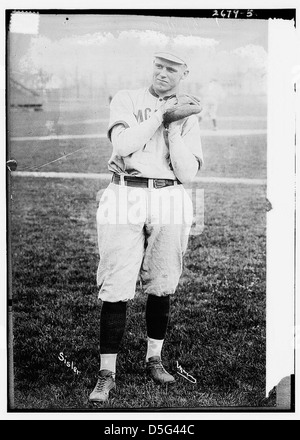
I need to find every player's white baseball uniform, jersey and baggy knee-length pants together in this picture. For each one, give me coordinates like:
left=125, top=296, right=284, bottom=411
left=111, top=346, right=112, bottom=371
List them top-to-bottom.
left=97, top=87, right=203, bottom=302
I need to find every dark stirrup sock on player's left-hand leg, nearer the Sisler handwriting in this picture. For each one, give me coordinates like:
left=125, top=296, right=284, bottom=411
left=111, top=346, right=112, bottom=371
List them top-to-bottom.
left=100, top=301, right=127, bottom=354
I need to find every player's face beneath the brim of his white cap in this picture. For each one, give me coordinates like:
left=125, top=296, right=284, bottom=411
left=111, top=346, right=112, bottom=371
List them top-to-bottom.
left=153, top=58, right=188, bottom=96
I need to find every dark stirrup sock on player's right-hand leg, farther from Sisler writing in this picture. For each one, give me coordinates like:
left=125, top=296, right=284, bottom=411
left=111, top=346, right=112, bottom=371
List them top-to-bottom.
left=146, top=295, right=170, bottom=339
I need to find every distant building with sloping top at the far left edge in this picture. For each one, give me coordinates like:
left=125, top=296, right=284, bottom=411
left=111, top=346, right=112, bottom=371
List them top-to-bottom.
left=8, top=78, right=43, bottom=110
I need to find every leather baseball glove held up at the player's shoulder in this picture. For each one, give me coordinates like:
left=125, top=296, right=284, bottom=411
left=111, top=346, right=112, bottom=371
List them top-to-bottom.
left=163, top=95, right=202, bottom=127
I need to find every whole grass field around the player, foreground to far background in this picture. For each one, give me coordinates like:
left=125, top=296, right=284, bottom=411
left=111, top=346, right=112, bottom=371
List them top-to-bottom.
left=11, top=93, right=274, bottom=411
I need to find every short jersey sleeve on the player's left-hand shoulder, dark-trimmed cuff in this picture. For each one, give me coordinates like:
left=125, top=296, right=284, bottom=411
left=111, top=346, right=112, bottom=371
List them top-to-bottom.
left=107, top=90, right=138, bottom=140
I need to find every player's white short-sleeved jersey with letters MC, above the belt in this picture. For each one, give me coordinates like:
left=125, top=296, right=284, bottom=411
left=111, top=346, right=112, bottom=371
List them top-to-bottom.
left=108, top=87, right=203, bottom=179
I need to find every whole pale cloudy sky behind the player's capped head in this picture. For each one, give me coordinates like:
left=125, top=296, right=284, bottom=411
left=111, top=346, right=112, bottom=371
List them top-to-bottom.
left=10, top=12, right=268, bottom=91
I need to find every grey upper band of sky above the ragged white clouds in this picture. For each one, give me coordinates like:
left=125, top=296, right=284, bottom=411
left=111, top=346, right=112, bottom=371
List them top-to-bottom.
left=35, top=12, right=267, bottom=50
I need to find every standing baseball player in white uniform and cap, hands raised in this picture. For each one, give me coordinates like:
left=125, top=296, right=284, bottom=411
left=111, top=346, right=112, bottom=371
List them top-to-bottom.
left=89, top=52, right=203, bottom=402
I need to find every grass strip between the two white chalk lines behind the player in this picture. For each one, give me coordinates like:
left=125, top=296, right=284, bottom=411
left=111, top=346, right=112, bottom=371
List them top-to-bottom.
left=12, top=135, right=266, bottom=178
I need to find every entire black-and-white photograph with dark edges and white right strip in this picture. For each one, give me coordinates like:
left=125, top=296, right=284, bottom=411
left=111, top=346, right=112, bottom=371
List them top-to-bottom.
left=5, top=4, right=299, bottom=420
